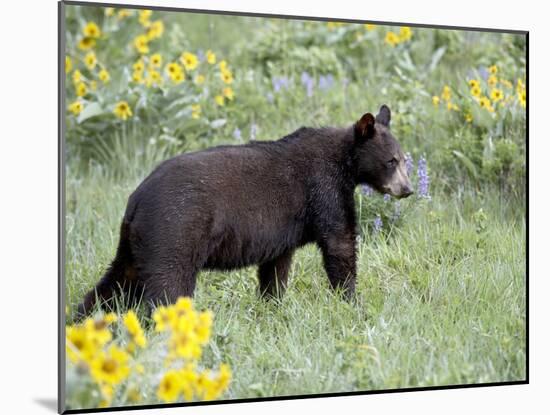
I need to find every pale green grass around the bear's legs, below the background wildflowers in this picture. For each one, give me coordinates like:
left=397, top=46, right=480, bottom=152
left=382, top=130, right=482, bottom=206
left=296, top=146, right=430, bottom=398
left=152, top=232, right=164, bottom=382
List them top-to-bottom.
left=66, top=141, right=526, bottom=399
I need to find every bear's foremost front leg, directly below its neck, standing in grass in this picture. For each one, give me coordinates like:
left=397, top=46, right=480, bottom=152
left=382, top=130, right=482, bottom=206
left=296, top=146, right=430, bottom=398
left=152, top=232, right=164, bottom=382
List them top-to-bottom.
left=319, top=232, right=357, bottom=300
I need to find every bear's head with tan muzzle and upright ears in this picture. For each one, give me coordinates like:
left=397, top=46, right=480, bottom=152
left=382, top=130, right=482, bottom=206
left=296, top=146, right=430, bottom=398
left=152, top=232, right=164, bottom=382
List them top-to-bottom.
left=354, top=105, right=413, bottom=198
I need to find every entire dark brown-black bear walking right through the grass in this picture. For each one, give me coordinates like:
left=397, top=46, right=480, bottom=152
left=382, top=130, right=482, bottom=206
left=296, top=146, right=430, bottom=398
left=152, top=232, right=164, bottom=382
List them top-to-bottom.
left=78, top=105, right=412, bottom=316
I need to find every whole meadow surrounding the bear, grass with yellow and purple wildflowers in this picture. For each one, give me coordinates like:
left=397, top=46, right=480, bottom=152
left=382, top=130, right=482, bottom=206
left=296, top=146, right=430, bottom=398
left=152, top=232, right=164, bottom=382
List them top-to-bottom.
left=65, top=6, right=526, bottom=409
